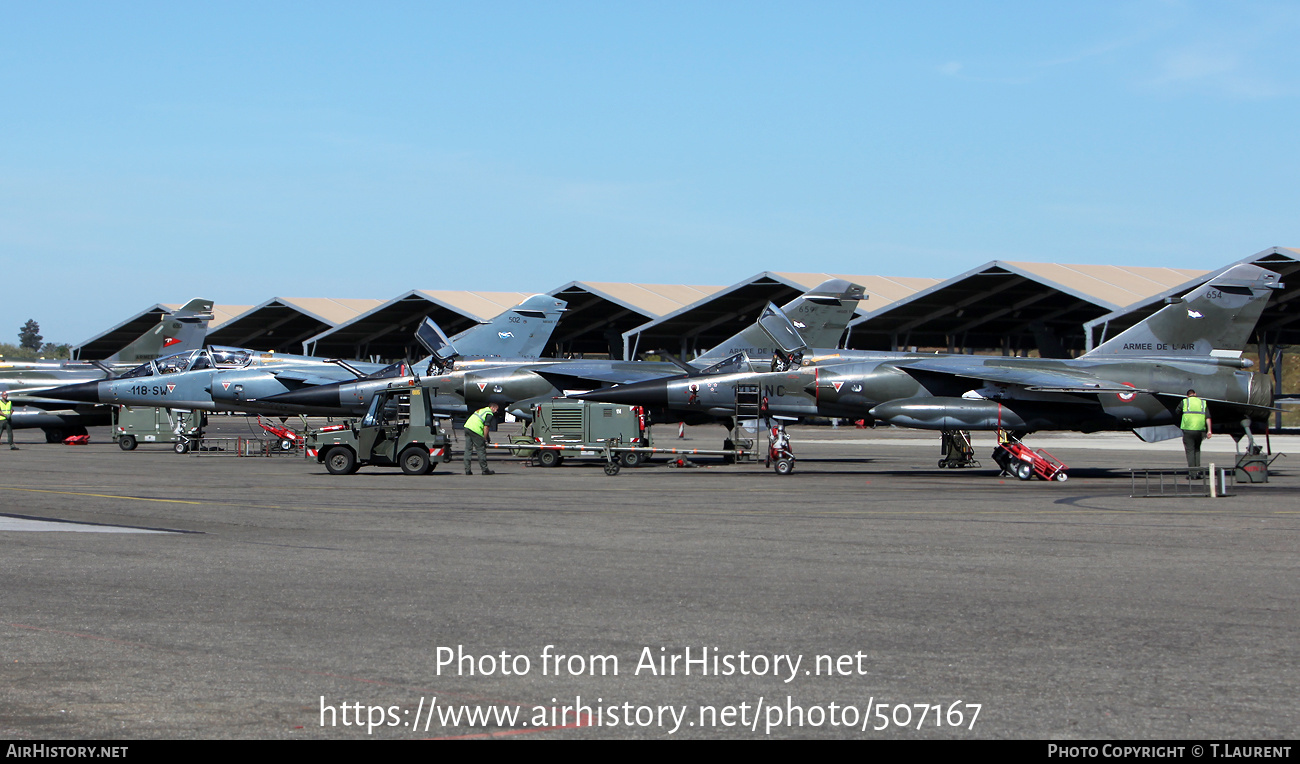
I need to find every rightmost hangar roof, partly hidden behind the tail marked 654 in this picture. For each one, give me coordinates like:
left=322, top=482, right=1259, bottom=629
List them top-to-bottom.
left=1084, top=247, right=1300, bottom=347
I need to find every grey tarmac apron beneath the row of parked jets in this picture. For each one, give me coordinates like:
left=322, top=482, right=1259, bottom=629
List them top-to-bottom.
left=0, top=418, right=1300, bottom=741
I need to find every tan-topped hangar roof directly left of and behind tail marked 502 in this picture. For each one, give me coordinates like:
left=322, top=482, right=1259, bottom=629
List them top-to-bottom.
left=303, top=290, right=532, bottom=359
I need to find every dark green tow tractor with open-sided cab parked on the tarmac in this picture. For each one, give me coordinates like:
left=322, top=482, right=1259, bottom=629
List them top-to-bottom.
left=304, top=382, right=451, bottom=474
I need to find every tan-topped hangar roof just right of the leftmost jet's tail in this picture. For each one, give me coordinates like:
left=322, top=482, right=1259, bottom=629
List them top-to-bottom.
left=208, top=298, right=382, bottom=353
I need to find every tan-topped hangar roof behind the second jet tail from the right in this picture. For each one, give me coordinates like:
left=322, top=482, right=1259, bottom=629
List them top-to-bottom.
left=624, top=270, right=939, bottom=357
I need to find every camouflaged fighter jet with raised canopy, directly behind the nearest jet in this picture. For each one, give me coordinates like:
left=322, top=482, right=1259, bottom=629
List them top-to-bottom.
left=257, top=279, right=865, bottom=417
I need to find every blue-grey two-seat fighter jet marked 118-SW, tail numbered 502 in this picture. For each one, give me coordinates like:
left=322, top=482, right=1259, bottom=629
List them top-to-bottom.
left=46, top=295, right=564, bottom=414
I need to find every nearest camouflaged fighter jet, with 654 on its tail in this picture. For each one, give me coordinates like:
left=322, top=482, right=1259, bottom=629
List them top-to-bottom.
left=576, top=265, right=1282, bottom=442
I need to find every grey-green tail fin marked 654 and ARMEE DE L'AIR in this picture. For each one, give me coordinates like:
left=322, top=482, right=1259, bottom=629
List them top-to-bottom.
left=1083, top=265, right=1282, bottom=359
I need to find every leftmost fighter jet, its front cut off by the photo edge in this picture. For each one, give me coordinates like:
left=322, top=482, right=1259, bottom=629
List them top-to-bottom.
left=0, top=299, right=212, bottom=443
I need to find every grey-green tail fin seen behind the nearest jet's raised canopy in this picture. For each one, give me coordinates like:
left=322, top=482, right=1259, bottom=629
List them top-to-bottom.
left=694, top=278, right=866, bottom=366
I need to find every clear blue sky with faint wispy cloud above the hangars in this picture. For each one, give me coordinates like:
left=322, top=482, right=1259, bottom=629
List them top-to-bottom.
left=0, top=0, right=1300, bottom=342
